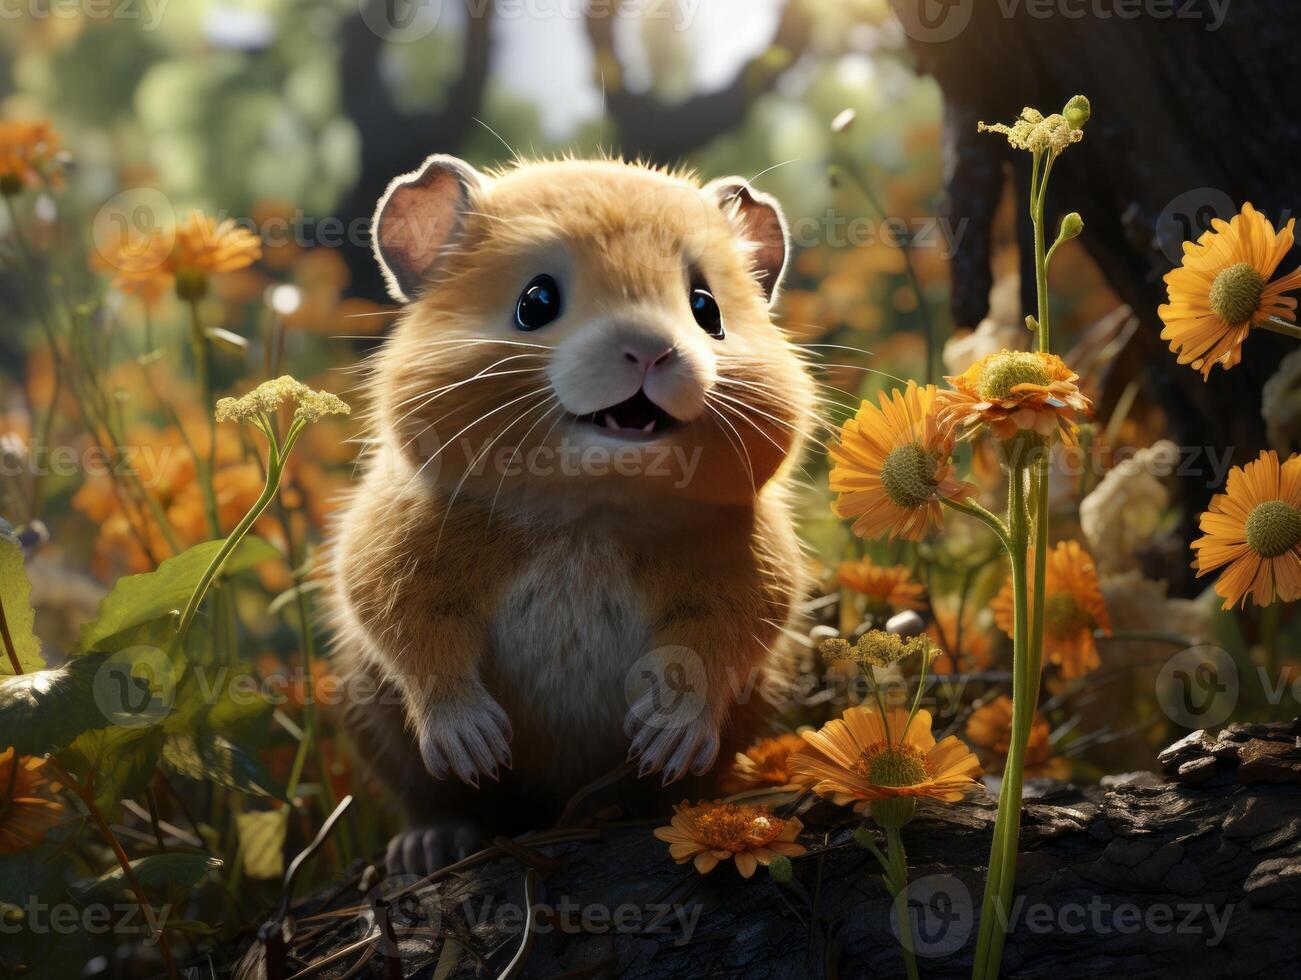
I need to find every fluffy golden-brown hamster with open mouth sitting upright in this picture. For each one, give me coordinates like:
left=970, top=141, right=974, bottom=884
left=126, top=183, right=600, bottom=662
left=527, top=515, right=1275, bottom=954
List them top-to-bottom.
left=329, top=155, right=814, bottom=872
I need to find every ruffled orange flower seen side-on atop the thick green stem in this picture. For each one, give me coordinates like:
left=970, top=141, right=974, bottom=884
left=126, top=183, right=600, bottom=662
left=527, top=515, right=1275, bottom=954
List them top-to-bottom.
left=937, top=350, right=1093, bottom=445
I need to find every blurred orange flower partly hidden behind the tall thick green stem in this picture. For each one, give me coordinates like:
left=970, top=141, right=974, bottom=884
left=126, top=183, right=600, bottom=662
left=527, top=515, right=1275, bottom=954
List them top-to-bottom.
left=990, top=541, right=1111, bottom=679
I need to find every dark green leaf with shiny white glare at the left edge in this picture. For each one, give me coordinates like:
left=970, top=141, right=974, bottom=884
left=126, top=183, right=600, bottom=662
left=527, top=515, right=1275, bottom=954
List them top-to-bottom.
left=0, top=653, right=108, bottom=755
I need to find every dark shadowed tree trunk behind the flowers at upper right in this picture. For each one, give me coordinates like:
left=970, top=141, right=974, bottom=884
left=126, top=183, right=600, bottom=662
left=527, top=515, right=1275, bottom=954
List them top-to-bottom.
left=892, top=0, right=1301, bottom=586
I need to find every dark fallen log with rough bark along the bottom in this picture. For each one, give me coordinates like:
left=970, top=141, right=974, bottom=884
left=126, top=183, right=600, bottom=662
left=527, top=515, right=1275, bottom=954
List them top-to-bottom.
left=234, top=721, right=1301, bottom=980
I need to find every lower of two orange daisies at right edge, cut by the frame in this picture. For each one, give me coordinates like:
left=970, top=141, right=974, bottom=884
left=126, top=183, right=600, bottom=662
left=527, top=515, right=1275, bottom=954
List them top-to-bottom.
left=1193, top=450, right=1301, bottom=609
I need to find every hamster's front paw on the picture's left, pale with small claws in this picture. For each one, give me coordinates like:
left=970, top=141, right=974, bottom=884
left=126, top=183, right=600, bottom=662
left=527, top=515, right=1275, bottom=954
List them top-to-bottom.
left=420, top=694, right=513, bottom=787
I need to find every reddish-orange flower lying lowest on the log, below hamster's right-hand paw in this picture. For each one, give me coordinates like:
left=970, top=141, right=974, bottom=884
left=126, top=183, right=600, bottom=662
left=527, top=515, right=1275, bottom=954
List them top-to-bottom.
left=654, top=800, right=805, bottom=878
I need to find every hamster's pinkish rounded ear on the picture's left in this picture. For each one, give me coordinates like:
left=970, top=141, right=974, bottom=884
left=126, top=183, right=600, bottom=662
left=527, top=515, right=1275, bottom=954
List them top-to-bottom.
left=371, top=154, right=485, bottom=303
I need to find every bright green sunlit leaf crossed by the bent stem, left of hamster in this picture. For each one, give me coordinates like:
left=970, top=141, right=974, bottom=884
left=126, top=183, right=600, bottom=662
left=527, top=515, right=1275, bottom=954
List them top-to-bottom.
left=78, top=536, right=281, bottom=653
